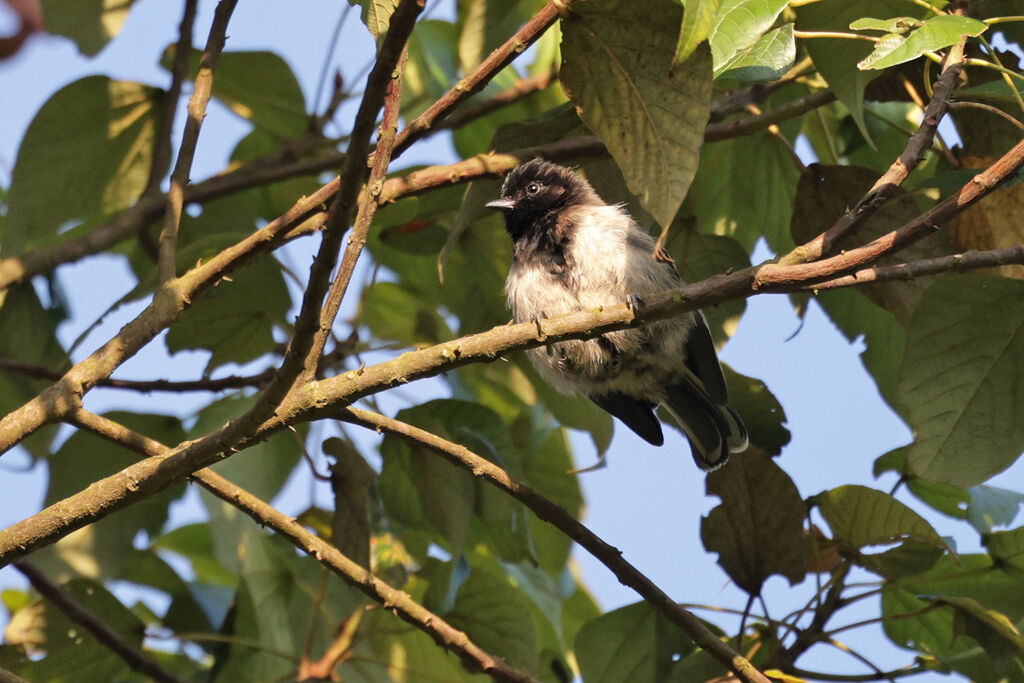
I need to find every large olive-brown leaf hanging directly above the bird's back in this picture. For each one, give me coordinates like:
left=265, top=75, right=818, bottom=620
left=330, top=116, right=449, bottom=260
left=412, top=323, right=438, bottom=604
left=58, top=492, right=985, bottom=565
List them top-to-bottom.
left=560, top=0, right=712, bottom=225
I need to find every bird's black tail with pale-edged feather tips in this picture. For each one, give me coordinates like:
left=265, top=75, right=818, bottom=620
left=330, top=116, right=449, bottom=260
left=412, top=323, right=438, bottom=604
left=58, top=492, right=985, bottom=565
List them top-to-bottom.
left=665, top=383, right=748, bottom=471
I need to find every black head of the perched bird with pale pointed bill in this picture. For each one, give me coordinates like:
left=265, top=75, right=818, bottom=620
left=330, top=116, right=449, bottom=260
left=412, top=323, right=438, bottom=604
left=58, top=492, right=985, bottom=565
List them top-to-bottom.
left=486, top=159, right=602, bottom=240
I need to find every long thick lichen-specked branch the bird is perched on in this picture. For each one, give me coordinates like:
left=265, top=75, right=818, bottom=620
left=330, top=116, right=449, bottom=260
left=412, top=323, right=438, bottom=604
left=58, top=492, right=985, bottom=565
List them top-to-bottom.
left=6, top=135, right=1024, bottom=566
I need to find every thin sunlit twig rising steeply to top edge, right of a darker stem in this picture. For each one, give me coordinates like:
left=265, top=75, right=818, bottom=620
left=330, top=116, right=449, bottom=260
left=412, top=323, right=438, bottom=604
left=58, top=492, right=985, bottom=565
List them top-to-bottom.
left=157, top=0, right=239, bottom=283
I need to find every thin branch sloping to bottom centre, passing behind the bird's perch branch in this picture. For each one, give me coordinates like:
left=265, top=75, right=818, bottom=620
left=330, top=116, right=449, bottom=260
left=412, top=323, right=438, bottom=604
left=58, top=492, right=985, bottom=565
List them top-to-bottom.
left=62, top=410, right=538, bottom=683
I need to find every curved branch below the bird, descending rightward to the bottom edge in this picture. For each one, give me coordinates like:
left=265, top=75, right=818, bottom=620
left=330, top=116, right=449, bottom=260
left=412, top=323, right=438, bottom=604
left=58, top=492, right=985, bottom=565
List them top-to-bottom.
left=341, top=408, right=769, bottom=683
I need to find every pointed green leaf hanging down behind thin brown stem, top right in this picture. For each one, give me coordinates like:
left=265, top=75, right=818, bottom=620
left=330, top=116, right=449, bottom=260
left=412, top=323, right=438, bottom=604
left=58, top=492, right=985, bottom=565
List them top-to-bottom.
left=797, top=0, right=909, bottom=141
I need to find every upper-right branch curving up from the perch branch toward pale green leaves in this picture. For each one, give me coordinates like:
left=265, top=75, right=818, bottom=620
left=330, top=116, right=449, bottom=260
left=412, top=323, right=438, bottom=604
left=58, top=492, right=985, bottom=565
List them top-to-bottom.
left=779, top=37, right=966, bottom=265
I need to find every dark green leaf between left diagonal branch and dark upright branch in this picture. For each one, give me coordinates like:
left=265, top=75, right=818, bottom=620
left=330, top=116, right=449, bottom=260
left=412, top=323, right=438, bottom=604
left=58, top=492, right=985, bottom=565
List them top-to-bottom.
left=166, top=258, right=292, bottom=376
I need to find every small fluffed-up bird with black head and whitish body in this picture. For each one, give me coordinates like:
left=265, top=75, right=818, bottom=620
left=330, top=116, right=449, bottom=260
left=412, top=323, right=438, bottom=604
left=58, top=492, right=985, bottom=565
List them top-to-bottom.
left=485, top=159, right=748, bottom=471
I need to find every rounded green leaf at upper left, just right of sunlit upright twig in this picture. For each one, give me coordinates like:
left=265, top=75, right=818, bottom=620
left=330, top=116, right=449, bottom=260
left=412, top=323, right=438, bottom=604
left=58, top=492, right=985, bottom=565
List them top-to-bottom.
left=161, top=46, right=309, bottom=138
